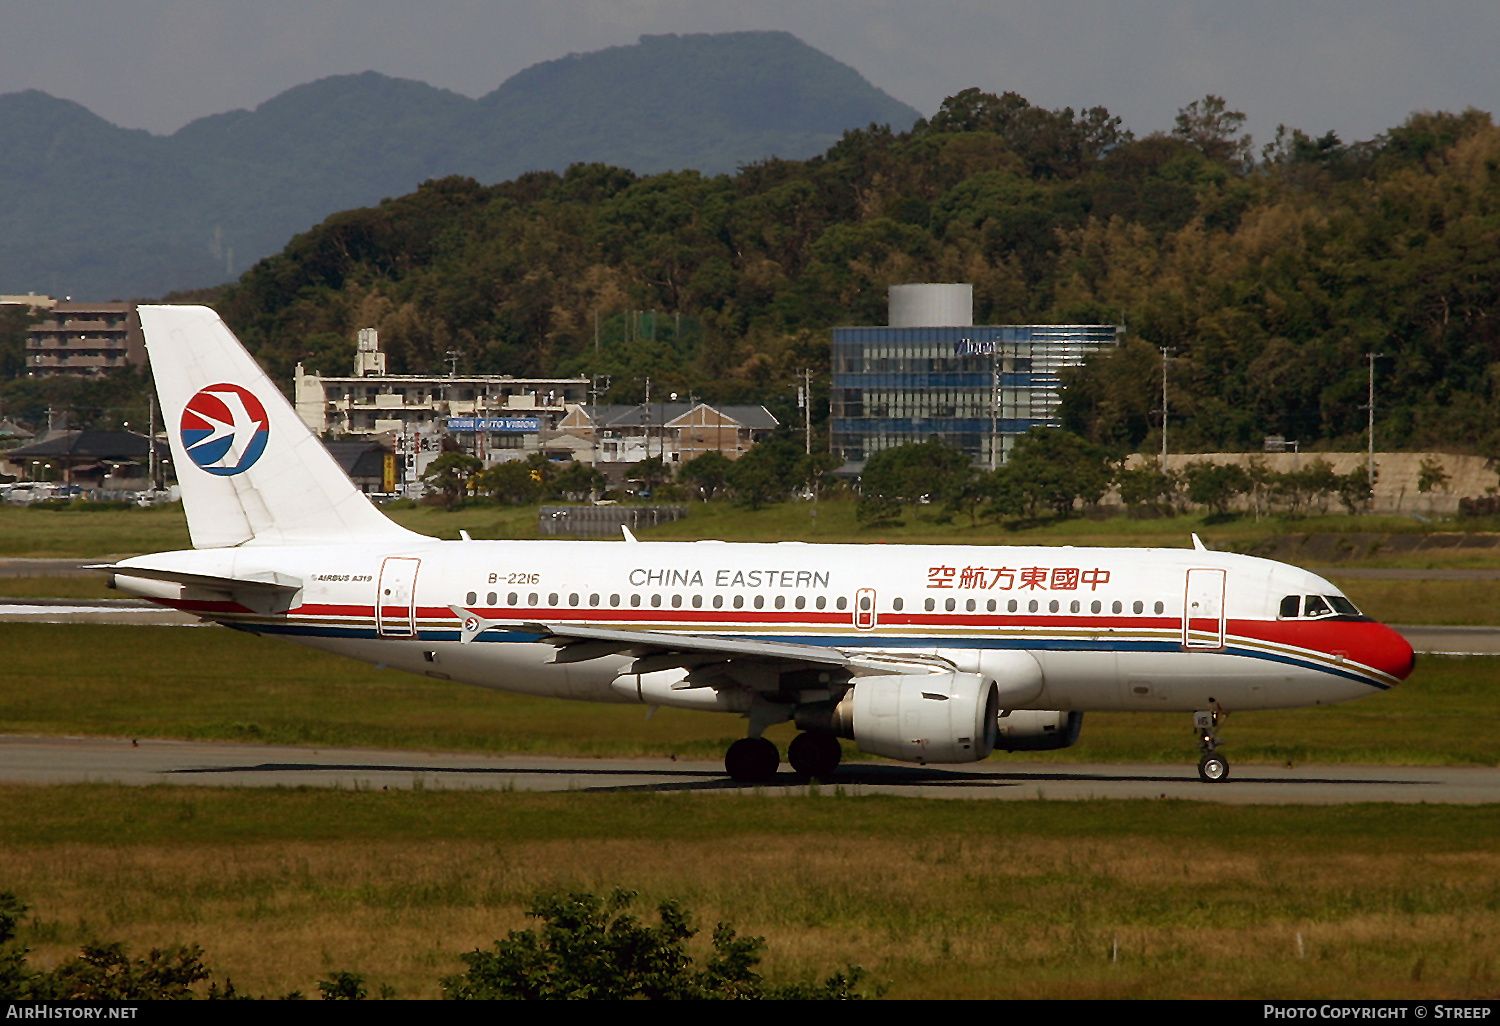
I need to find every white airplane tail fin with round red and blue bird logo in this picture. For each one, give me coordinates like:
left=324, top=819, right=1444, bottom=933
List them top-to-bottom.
left=140, top=306, right=420, bottom=549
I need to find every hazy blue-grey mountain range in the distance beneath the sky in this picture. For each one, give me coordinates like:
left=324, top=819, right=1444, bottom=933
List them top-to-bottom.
left=0, top=32, right=918, bottom=300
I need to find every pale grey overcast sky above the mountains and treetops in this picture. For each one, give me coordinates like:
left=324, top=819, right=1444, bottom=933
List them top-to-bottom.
left=0, top=0, right=1500, bottom=151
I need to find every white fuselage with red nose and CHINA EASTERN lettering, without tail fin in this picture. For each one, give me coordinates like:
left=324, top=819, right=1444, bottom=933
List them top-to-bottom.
left=117, top=539, right=1412, bottom=711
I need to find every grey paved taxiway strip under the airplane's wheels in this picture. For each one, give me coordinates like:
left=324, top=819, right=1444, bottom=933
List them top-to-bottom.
left=0, top=735, right=1500, bottom=806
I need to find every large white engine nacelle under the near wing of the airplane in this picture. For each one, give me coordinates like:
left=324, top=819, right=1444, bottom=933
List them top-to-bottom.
left=836, top=674, right=1001, bottom=762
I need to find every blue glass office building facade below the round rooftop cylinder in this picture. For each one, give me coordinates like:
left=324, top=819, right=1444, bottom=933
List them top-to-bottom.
left=831, top=324, right=1125, bottom=473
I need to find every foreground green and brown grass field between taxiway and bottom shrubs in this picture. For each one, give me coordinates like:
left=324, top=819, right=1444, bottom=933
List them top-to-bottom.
left=0, top=786, right=1500, bottom=999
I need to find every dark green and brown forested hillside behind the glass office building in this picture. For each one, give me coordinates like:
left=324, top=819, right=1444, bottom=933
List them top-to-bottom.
left=221, top=90, right=1500, bottom=452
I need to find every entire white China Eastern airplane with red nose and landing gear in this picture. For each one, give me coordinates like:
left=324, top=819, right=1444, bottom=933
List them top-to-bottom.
left=98, top=306, right=1415, bottom=783
